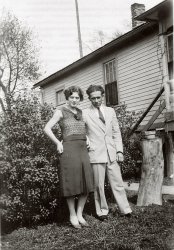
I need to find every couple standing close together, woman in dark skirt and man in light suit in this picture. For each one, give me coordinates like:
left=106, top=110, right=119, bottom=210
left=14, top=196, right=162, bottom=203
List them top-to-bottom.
left=44, top=85, right=132, bottom=229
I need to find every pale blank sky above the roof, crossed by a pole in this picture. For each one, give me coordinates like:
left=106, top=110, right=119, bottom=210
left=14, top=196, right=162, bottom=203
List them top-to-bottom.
left=0, top=0, right=162, bottom=79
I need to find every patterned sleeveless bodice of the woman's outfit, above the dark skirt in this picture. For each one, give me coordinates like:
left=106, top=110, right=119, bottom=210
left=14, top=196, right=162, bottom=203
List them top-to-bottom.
left=59, top=107, right=86, bottom=138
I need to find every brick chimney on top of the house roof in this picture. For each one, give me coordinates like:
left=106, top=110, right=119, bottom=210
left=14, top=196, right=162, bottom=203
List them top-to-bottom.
left=131, top=3, right=145, bottom=28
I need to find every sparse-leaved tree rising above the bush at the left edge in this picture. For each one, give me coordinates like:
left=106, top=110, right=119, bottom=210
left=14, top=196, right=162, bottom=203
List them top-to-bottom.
left=0, top=13, right=39, bottom=112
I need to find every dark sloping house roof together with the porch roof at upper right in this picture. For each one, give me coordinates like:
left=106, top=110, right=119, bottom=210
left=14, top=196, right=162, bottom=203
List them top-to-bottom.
left=33, top=0, right=167, bottom=88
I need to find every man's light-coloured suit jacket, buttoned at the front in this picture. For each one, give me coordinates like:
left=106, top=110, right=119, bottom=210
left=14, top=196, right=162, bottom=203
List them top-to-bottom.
left=83, top=106, right=123, bottom=163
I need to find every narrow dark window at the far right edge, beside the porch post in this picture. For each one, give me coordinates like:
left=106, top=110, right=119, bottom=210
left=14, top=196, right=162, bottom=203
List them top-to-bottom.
left=167, top=27, right=173, bottom=79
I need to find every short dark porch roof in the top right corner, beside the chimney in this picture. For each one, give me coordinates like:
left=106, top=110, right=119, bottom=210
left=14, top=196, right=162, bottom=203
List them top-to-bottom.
left=135, top=0, right=173, bottom=21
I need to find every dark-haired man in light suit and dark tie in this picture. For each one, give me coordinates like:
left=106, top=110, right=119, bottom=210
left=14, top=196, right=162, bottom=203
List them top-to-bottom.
left=83, top=85, right=132, bottom=220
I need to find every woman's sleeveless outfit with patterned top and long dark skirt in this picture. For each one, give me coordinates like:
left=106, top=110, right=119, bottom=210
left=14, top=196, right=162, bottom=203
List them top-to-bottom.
left=59, top=107, right=94, bottom=197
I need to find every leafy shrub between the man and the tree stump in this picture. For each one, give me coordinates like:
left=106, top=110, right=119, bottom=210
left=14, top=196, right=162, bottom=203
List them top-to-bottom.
left=114, top=105, right=142, bottom=179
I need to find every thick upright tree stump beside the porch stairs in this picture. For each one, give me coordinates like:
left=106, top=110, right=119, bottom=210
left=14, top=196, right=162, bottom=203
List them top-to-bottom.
left=137, top=131, right=164, bottom=206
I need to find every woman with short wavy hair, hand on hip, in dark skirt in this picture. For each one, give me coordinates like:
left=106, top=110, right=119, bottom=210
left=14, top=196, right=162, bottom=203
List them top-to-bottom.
left=44, top=86, right=93, bottom=229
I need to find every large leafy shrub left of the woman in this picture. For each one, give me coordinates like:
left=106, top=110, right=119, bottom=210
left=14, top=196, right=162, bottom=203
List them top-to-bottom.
left=0, top=96, right=60, bottom=227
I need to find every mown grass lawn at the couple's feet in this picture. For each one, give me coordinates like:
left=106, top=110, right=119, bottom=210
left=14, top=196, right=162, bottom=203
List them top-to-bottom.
left=2, top=193, right=174, bottom=250
